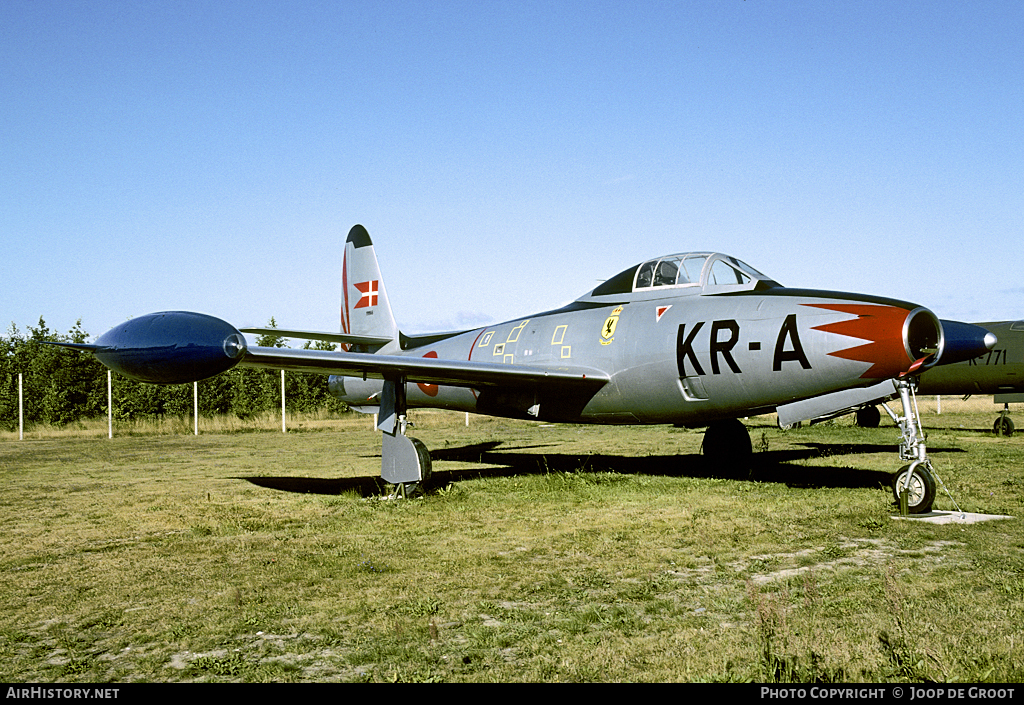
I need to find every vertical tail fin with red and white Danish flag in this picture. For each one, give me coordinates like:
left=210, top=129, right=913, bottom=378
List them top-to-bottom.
left=341, top=225, right=399, bottom=351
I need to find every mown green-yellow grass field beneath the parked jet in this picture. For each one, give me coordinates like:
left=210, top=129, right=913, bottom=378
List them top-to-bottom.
left=0, top=401, right=1024, bottom=682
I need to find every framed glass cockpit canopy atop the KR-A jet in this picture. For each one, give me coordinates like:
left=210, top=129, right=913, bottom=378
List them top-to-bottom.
left=590, top=252, right=779, bottom=296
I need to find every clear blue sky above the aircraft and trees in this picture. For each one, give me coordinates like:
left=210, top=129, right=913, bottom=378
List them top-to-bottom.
left=0, top=0, right=1024, bottom=336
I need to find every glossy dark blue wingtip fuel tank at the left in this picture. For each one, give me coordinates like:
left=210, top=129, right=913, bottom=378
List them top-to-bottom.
left=93, top=310, right=247, bottom=384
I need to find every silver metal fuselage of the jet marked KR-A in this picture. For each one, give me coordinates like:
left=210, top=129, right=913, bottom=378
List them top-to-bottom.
left=331, top=283, right=934, bottom=426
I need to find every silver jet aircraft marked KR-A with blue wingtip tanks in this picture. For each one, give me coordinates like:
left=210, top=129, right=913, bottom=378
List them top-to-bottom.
left=51, top=225, right=995, bottom=512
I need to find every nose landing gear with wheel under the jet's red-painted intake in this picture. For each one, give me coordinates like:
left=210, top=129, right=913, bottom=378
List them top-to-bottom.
left=882, top=378, right=959, bottom=514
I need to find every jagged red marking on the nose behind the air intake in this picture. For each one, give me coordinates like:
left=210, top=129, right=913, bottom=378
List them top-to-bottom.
left=804, top=303, right=913, bottom=379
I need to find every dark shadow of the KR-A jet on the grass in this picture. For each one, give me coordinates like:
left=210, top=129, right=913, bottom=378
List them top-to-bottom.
left=239, top=441, right=965, bottom=496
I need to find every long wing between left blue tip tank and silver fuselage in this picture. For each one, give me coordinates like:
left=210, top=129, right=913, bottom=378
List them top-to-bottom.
left=239, top=347, right=610, bottom=391
